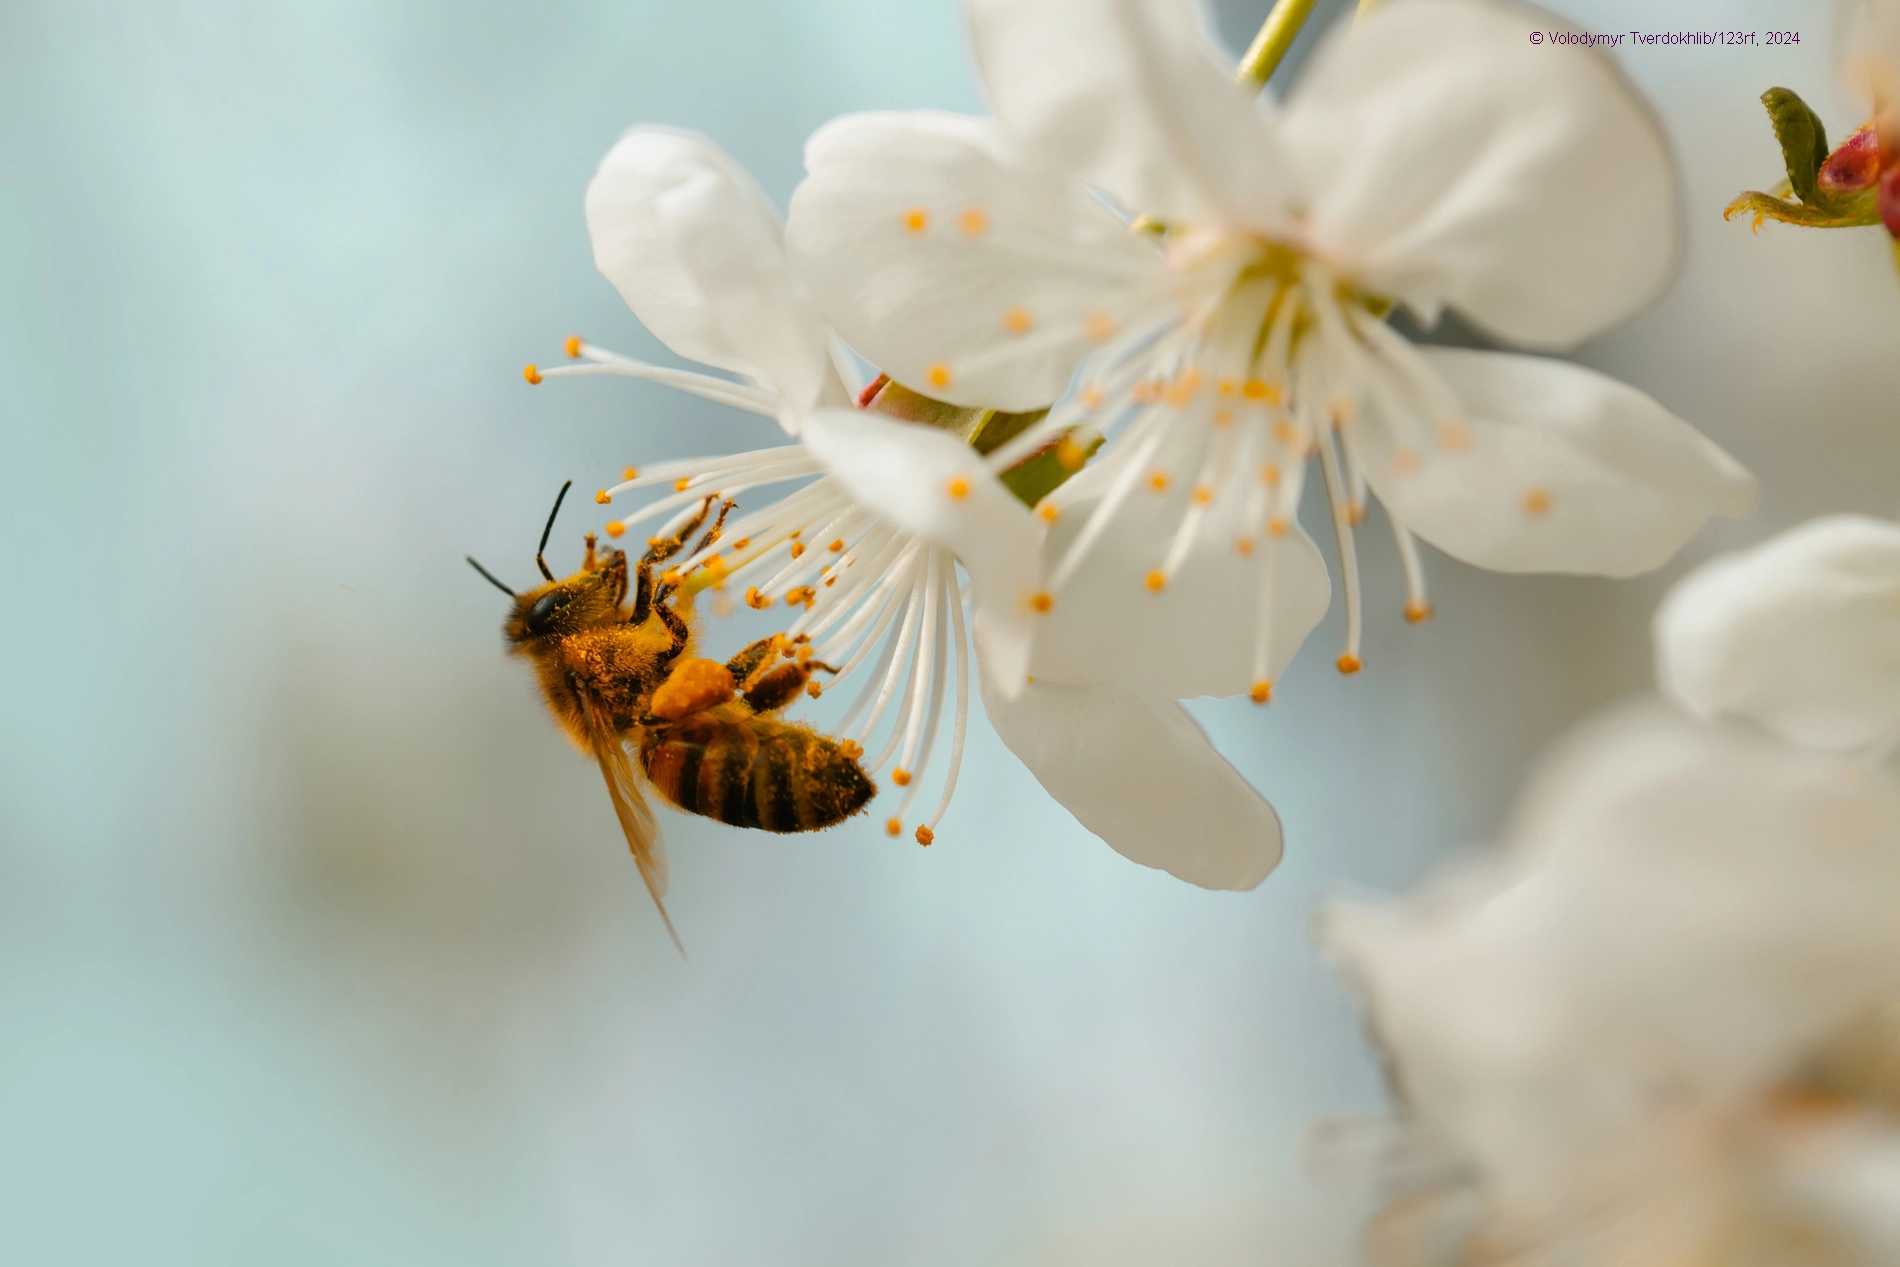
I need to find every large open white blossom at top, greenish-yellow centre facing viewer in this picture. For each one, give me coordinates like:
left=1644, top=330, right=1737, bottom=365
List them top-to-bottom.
left=787, top=0, right=1754, bottom=687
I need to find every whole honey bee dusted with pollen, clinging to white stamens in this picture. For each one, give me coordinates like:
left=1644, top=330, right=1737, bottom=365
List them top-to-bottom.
left=467, top=481, right=878, bottom=946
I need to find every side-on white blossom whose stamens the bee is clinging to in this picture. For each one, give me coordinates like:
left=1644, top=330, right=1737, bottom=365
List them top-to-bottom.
left=528, top=127, right=1281, bottom=889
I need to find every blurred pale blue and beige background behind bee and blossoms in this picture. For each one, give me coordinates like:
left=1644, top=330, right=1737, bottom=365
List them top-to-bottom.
left=0, top=0, right=1900, bottom=1265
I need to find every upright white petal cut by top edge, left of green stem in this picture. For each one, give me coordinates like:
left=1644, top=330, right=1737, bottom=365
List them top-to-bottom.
left=969, top=0, right=1290, bottom=230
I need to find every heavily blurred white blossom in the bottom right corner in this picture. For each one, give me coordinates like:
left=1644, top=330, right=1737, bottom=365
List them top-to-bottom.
left=1324, top=707, right=1900, bottom=1267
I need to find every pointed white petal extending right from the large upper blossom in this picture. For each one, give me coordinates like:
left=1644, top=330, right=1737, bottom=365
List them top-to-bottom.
left=1349, top=348, right=1756, bottom=576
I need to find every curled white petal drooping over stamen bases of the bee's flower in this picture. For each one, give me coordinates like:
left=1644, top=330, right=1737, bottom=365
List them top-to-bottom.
left=804, top=408, right=1043, bottom=693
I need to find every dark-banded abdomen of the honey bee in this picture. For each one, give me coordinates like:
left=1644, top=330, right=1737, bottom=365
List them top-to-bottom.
left=640, top=705, right=878, bottom=832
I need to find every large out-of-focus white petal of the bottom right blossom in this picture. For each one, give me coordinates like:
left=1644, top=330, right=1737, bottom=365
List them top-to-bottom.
left=1326, top=707, right=1900, bottom=1204
